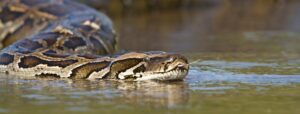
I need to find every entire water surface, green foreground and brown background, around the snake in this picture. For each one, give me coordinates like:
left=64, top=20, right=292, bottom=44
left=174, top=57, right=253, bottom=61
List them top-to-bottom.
left=0, top=0, right=300, bottom=114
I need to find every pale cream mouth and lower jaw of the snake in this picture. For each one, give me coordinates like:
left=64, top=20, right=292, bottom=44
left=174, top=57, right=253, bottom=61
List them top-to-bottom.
left=135, top=67, right=188, bottom=81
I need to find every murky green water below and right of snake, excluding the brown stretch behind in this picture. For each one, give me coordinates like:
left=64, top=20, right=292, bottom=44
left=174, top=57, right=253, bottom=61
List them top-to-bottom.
left=0, top=53, right=300, bottom=114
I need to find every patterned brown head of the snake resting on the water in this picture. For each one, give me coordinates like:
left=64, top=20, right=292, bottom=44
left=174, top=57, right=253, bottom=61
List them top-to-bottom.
left=110, top=52, right=189, bottom=81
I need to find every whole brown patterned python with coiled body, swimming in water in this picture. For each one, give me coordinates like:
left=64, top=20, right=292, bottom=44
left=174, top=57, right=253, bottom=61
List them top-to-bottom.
left=0, top=0, right=189, bottom=80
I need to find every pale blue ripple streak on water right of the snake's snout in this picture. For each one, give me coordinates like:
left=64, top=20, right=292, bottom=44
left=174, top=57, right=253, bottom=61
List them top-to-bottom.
left=187, top=69, right=300, bottom=85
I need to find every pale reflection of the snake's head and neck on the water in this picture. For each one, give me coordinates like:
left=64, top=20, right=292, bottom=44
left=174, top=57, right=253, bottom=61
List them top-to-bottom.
left=71, top=80, right=189, bottom=107
